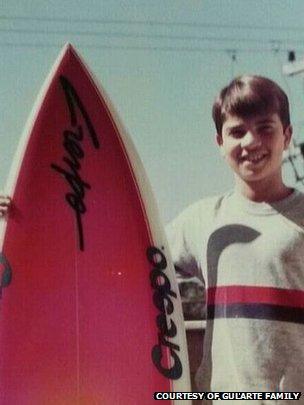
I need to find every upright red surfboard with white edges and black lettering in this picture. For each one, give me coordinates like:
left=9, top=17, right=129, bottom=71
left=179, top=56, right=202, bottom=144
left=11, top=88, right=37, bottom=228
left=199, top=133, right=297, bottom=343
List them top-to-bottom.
left=0, top=44, right=190, bottom=405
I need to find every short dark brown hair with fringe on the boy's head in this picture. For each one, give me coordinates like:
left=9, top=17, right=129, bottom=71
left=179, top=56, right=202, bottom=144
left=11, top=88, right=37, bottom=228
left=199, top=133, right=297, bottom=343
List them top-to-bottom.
left=212, top=75, right=290, bottom=135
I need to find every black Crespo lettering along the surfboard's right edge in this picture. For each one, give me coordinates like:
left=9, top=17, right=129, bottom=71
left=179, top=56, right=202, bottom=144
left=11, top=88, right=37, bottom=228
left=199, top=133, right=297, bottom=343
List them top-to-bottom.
left=146, top=246, right=183, bottom=380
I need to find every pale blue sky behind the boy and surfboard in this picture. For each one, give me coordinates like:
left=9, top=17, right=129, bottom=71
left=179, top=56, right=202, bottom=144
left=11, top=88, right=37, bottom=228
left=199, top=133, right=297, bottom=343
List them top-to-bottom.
left=0, top=0, right=304, bottom=222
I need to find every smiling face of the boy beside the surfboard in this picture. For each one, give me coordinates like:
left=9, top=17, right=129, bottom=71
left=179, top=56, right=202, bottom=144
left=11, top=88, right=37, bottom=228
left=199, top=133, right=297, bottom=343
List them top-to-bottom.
left=217, top=113, right=292, bottom=183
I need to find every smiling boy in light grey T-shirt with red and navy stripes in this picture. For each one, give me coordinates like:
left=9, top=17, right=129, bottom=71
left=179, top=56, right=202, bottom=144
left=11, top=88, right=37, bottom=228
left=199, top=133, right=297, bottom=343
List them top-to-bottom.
left=168, top=76, right=304, bottom=398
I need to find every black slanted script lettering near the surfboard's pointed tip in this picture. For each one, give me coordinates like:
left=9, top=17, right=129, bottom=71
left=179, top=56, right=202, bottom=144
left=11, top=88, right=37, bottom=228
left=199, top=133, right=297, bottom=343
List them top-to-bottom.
left=51, top=75, right=100, bottom=251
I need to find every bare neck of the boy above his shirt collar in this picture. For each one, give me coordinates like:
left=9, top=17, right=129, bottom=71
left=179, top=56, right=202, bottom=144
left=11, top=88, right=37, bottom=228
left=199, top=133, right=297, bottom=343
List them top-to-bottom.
left=235, top=177, right=293, bottom=203
